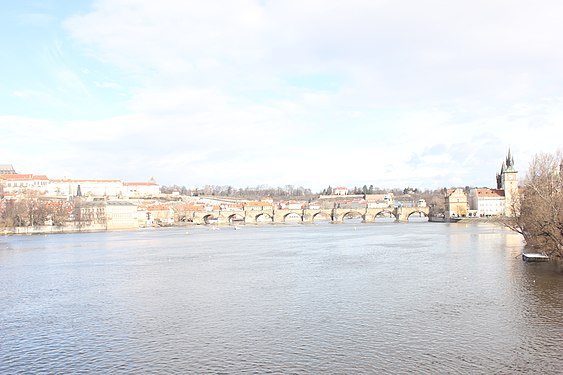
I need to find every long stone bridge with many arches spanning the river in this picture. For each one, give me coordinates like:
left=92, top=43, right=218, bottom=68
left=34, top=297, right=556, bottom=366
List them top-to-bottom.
left=185, top=207, right=429, bottom=224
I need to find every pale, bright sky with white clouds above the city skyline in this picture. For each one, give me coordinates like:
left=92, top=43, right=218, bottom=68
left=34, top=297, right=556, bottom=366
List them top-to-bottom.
left=0, top=0, right=563, bottom=191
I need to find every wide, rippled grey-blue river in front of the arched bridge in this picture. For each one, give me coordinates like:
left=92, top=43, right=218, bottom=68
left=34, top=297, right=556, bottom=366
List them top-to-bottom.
left=0, top=223, right=563, bottom=374
